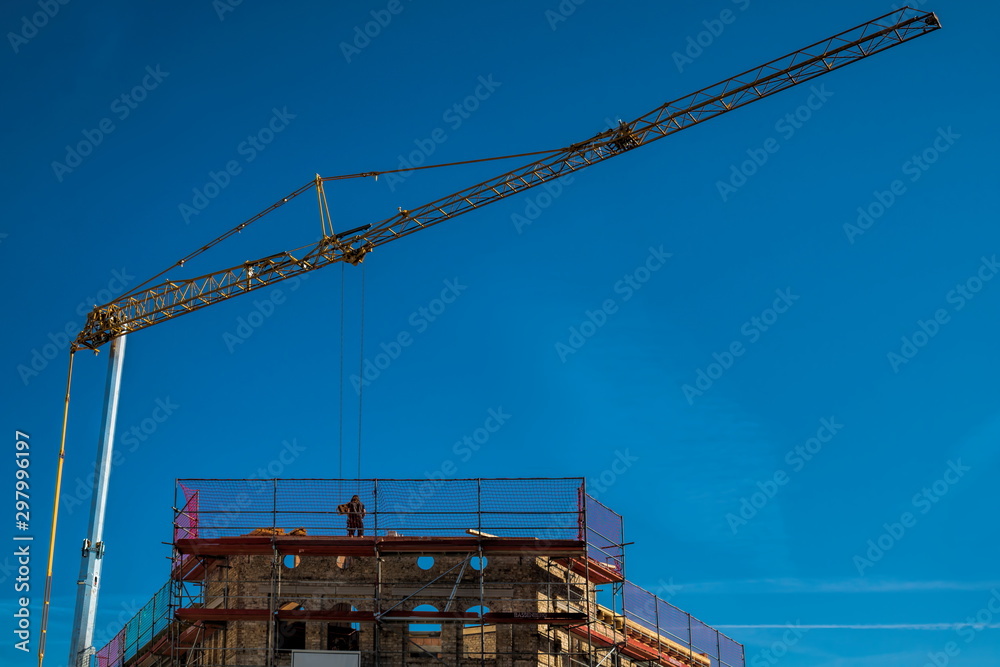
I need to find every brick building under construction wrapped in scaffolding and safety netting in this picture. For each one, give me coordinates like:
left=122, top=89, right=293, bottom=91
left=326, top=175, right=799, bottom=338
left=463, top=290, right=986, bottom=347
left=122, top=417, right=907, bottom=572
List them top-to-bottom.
left=92, top=478, right=744, bottom=667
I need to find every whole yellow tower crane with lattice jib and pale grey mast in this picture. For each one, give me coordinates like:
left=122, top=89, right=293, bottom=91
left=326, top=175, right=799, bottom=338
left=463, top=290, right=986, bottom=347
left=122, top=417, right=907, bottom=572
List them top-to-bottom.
left=38, top=7, right=941, bottom=667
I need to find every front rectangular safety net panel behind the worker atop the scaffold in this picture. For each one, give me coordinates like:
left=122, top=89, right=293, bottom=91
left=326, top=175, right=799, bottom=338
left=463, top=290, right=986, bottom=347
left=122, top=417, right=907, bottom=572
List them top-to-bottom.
left=174, top=478, right=588, bottom=540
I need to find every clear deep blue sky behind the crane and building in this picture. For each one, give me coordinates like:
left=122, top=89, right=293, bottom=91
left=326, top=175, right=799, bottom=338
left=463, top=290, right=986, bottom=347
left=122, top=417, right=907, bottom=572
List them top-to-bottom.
left=0, top=0, right=1000, bottom=667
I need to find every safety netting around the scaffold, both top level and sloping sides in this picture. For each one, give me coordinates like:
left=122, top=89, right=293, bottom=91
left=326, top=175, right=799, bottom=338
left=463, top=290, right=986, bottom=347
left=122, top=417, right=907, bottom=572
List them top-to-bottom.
left=90, top=478, right=745, bottom=667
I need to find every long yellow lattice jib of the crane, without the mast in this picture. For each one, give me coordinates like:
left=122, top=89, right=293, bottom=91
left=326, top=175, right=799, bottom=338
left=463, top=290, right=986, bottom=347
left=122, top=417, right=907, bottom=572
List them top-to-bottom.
left=73, top=7, right=941, bottom=350
